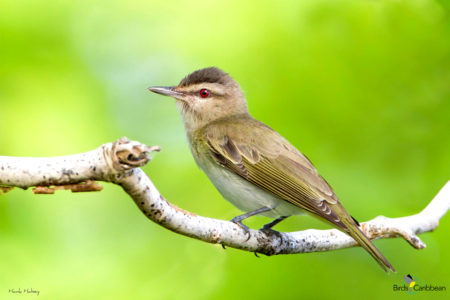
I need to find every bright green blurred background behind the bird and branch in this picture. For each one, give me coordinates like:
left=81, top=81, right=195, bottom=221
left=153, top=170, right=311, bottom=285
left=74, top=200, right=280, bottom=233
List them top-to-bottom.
left=0, top=0, right=450, bottom=299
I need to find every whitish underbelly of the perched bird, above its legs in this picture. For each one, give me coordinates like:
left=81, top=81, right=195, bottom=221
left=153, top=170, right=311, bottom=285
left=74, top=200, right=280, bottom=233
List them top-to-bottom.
left=199, top=156, right=304, bottom=218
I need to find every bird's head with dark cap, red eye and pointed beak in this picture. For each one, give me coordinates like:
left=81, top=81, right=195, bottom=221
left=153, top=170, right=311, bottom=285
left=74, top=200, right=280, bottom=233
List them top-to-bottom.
left=149, top=67, right=248, bottom=130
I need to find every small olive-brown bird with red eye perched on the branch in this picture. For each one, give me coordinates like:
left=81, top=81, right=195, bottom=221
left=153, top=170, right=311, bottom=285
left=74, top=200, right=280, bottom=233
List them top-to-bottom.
left=149, top=67, right=395, bottom=272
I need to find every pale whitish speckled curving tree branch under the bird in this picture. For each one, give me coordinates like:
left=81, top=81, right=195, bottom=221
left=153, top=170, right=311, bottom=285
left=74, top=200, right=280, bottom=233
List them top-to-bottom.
left=0, top=138, right=450, bottom=255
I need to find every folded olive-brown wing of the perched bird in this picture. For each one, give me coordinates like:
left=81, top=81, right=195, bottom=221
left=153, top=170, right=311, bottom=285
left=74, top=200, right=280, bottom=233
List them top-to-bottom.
left=202, top=120, right=346, bottom=229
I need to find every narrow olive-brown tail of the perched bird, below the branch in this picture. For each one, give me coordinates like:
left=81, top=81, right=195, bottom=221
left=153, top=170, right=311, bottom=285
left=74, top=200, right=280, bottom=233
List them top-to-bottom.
left=341, top=214, right=396, bottom=272
